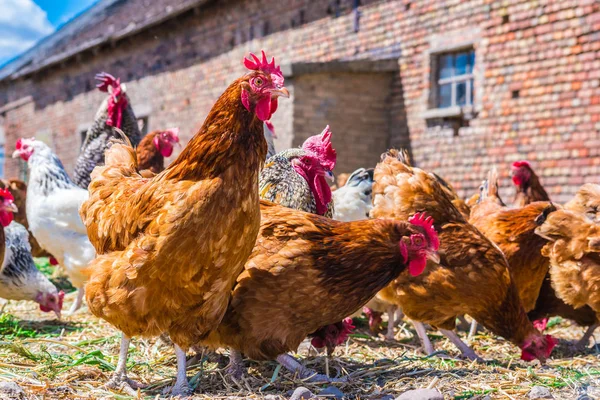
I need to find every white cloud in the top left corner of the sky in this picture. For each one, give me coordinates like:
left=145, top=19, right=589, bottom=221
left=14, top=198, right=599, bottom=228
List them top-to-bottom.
left=0, top=0, right=54, bottom=64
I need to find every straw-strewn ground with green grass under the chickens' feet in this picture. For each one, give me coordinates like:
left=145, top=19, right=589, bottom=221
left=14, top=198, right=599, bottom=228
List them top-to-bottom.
left=0, top=261, right=600, bottom=400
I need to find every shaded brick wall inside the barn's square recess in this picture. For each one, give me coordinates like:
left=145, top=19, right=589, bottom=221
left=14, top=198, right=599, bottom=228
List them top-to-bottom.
left=291, top=73, right=392, bottom=172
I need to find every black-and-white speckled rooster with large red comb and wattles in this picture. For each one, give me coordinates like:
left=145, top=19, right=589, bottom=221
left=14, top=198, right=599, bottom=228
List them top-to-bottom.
left=258, top=126, right=336, bottom=218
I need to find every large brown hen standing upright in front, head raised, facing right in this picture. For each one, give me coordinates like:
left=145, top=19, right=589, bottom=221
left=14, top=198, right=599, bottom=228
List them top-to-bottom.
left=81, top=52, right=289, bottom=395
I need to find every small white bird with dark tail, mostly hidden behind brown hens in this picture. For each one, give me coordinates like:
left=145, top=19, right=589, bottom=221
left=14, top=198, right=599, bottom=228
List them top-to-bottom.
left=333, top=168, right=373, bottom=222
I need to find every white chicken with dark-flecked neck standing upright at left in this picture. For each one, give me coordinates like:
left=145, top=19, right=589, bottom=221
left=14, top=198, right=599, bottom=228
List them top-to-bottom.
left=13, top=138, right=96, bottom=315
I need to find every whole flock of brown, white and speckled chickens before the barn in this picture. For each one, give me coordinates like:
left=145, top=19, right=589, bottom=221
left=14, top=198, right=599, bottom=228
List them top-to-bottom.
left=0, top=52, right=600, bottom=396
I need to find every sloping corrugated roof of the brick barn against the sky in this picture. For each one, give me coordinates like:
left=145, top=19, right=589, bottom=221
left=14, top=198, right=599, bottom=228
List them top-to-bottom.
left=0, top=0, right=210, bottom=81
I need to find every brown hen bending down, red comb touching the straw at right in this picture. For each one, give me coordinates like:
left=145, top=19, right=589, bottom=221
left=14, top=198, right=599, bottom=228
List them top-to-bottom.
left=371, top=150, right=556, bottom=362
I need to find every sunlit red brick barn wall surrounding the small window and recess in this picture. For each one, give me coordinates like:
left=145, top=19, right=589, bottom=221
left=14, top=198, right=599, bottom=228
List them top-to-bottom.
left=0, top=0, right=600, bottom=201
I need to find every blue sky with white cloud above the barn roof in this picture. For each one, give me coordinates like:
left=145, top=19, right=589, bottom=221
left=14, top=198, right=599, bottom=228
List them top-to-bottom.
left=0, top=0, right=97, bottom=65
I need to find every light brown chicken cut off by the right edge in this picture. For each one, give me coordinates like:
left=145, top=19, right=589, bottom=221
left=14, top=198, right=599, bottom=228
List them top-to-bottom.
left=536, top=210, right=600, bottom=343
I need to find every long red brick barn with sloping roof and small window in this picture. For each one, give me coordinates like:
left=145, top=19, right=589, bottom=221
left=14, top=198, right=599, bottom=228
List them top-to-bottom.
left=0, top=0, right=600, bottom=201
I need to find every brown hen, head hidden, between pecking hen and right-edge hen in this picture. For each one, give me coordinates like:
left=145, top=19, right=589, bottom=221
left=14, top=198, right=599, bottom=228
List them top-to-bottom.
left=469, top=171, right=556, bottom=311
